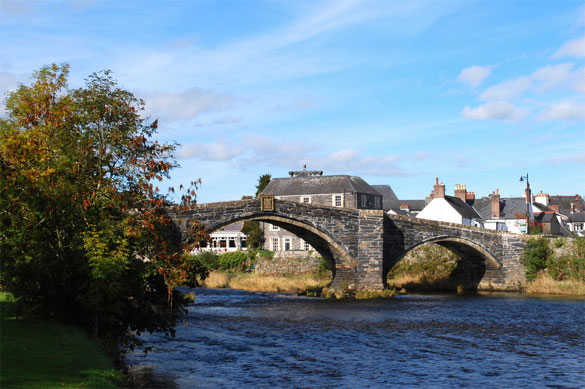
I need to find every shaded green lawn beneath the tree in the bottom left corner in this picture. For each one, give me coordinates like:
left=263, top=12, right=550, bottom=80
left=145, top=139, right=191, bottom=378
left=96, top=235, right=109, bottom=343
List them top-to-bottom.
left=0, top=292, right=126, bottom=389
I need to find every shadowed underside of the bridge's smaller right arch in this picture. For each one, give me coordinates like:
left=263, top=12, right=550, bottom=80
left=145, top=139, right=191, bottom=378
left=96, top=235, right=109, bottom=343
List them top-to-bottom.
left=384, top=236, right=502, bottom=291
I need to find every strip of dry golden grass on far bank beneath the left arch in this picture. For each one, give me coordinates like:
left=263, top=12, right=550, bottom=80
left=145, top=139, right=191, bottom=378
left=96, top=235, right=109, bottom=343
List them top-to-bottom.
left=203, top=271, right=331, bottom=294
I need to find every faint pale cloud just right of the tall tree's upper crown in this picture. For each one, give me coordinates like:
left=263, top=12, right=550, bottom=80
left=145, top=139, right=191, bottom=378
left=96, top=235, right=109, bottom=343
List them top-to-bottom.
left=142, top=87, right=235, bottom=120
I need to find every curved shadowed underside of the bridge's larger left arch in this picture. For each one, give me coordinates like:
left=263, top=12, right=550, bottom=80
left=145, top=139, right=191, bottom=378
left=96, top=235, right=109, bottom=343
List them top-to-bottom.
left=207, top=214, right=357, bottom=279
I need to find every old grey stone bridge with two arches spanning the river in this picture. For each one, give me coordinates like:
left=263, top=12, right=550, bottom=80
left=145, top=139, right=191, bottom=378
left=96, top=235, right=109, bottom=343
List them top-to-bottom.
left=175, top=198, right=526, bottom=290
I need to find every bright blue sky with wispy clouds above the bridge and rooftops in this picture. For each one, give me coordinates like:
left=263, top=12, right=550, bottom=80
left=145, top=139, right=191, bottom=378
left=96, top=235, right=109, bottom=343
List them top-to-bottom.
left=0, top=0, right=585, bottom=202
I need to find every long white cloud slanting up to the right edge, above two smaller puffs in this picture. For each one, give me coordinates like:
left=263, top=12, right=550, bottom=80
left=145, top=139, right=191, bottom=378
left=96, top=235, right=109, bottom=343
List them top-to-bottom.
left=479, top=63, right=585, bottom=100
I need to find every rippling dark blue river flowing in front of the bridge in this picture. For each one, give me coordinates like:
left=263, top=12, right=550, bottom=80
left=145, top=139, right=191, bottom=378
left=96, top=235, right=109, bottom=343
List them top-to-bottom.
left=127, top=289, right=585, bottom=388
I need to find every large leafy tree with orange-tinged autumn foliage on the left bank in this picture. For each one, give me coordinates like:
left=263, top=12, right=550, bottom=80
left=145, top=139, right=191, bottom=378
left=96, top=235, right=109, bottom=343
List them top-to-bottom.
left=0, top=65, right=204, bottom=345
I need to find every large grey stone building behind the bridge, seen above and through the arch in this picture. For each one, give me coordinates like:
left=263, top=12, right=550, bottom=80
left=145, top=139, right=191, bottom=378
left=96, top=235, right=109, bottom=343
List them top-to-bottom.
left=262, top=170, right=384, bottom=257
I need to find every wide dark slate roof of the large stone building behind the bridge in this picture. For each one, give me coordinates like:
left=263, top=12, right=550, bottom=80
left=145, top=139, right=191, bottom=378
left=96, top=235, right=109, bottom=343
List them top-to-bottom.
left=262, top=175, right=380, bottom=196
